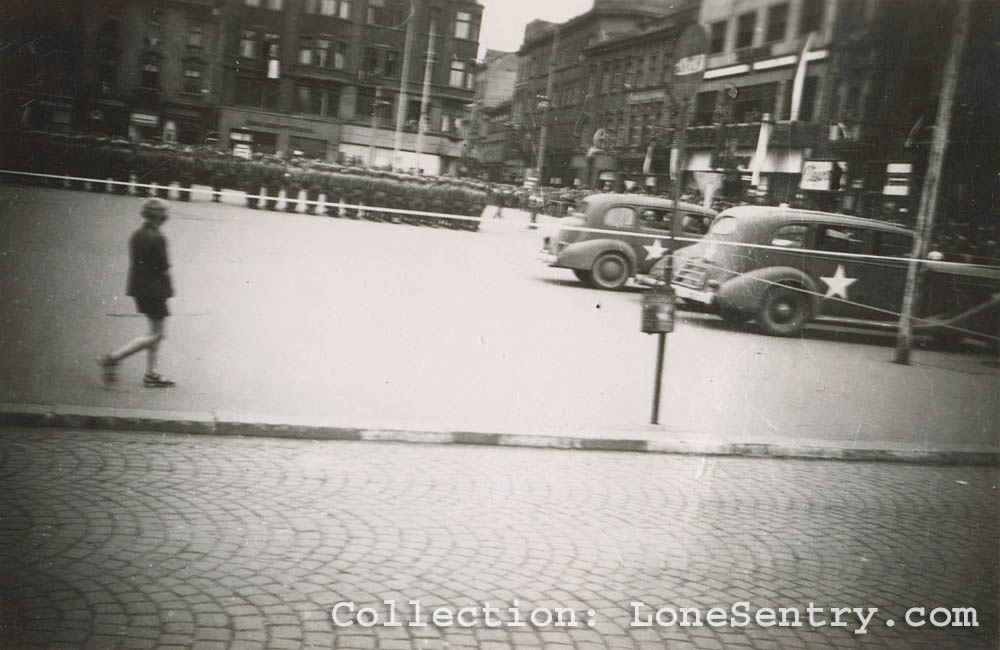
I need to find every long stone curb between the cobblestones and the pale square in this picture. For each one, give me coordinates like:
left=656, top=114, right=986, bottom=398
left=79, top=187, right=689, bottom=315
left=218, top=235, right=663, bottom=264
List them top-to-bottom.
left=0, top=404, right=1000, bottom=466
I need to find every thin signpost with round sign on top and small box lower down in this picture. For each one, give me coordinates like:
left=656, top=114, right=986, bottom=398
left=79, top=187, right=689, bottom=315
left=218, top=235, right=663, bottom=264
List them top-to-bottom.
left=642, top=23, right=708, bottom=424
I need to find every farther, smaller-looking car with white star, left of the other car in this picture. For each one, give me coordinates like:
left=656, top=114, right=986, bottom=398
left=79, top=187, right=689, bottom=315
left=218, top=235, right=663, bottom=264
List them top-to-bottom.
left=538, top=193, right=717, bottom=289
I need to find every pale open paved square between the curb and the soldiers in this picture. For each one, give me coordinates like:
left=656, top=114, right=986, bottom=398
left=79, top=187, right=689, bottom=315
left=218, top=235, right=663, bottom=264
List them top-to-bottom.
left=0, top=185, right=1000, bottom=451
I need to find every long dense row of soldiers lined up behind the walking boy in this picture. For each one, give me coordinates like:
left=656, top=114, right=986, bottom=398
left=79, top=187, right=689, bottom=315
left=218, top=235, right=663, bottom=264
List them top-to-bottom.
left=0, top=131, right=487, bottom=230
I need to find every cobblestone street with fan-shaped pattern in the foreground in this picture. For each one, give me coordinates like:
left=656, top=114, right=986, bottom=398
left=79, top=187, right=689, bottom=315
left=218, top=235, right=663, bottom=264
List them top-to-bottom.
left=0, top=429, right=998, bottom=650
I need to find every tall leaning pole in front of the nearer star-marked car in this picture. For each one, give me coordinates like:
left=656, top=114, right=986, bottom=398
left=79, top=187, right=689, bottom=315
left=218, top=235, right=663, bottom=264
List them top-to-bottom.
left=893, top=0, right=971, bottom=365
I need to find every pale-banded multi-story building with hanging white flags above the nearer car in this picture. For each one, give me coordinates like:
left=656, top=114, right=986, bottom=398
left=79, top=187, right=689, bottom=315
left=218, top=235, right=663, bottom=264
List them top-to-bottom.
left=685, top=0, right=838, bottom=202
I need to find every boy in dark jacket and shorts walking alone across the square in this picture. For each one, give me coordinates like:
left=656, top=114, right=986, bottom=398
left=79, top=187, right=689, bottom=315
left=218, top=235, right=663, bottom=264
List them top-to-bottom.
left=97, top=198, right=174, bottom=388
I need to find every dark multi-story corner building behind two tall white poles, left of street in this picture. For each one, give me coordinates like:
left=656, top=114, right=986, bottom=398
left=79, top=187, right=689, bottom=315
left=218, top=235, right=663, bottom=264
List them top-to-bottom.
left=219, top=0, right=482, bottom=174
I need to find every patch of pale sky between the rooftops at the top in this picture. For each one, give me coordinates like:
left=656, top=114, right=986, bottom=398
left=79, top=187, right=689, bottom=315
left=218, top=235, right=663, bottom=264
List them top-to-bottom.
left=479, top=0, right=594, bottom=56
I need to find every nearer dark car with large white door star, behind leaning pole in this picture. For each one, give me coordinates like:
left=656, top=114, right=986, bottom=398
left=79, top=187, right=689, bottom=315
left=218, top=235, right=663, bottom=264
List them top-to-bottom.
left=651, top=205, right=1000, bottom=342
